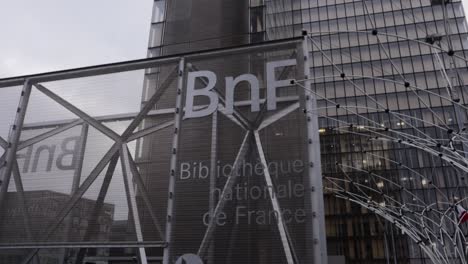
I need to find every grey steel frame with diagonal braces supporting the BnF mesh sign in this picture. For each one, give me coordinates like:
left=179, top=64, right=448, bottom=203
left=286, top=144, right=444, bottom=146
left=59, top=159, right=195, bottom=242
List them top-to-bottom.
left=0, top=39, right=326, bottom=264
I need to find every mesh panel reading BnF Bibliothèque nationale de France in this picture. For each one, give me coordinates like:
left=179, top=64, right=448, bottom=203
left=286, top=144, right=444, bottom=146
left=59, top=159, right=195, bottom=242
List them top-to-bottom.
left=150, top=39, right=316, bottom=263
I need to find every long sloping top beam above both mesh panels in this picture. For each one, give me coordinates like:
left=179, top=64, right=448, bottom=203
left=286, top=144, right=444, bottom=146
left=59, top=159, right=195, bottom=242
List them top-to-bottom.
left=0, top=38, right=302, bottom=88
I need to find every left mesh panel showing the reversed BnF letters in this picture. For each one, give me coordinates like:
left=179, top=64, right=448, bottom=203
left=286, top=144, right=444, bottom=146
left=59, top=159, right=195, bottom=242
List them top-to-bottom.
left=0, top=58, right=177, bottom=263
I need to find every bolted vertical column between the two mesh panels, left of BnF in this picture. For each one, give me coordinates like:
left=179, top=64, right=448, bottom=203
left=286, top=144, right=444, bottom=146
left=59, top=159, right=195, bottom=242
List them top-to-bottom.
left=163, top=58, right=185, bottom=264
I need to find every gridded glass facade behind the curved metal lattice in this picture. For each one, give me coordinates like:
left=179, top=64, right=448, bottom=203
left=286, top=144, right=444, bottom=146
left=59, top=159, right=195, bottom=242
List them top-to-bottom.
left=250, top=0, right=468, bottom=263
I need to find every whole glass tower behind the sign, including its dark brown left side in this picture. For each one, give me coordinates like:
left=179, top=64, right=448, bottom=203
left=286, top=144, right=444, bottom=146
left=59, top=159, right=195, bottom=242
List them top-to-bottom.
left=142, top=0, right=468, bottom=263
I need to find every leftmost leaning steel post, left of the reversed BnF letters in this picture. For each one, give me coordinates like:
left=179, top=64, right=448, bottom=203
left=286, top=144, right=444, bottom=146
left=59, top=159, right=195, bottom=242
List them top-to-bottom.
left=0, top=80, right=31, bottom=210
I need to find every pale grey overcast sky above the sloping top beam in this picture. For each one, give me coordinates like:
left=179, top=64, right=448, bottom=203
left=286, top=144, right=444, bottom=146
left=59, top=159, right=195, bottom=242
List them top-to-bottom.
left=0, top=0, right=468, bottom=78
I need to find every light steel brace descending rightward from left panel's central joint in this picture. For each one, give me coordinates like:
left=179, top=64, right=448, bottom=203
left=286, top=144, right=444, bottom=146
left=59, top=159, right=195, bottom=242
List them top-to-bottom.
left=120, top=143, right=148, bottom=264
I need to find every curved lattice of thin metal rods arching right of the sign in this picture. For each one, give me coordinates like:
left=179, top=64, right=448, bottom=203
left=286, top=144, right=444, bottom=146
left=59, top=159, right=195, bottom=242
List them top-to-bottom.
left=296, top=25, right=468, bottom=263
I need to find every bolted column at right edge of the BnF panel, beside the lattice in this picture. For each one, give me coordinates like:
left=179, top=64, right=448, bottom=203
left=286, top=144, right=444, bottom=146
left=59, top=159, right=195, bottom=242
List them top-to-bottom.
left=302, top=31, right=328, bottom=264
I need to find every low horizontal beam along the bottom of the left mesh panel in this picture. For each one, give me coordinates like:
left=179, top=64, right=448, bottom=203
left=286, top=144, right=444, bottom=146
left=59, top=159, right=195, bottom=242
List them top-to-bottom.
left=0, top=241, right=167, bottom=250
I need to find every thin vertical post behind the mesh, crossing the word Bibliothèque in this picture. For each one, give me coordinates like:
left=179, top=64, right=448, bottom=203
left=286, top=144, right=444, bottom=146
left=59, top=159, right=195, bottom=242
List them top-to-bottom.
left=208, top=111, right=218, bottom=264
